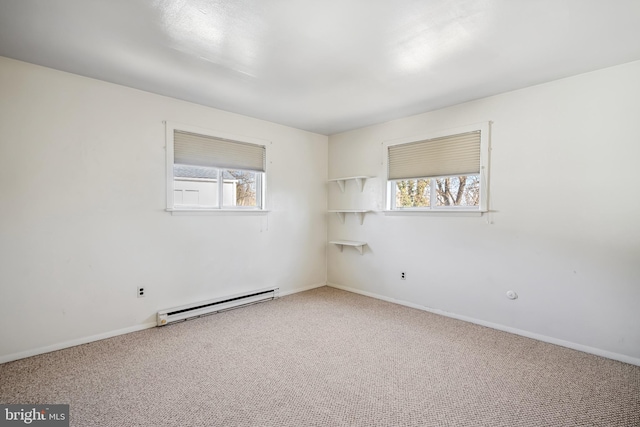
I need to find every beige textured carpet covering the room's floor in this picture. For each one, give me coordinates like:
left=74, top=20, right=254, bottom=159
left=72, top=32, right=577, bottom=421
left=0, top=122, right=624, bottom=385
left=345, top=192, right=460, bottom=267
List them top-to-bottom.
left=0, top=287, right=640, bottom=427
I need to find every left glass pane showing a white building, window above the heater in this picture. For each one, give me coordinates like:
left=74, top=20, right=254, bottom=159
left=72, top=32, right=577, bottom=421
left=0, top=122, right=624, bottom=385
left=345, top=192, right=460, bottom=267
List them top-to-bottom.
left=173, top=165, right=218, bottom=207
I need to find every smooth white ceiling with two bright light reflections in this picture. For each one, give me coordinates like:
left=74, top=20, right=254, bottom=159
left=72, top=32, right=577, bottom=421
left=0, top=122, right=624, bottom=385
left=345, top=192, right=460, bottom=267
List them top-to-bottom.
left=0, top=0, right=640, bottom=134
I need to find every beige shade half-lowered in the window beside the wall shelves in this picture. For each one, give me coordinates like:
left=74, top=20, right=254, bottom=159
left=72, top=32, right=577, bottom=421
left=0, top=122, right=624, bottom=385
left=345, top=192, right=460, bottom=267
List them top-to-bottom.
left=389, top=131, right=480, bottom=180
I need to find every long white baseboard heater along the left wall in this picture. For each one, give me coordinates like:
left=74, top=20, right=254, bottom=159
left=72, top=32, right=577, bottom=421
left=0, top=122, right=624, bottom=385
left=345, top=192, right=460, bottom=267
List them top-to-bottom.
left=157, top=288, right=280, bottom=326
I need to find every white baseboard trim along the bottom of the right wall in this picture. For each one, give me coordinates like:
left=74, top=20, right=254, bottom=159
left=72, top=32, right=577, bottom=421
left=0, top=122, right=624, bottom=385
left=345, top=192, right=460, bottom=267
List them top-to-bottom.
left=327, top=282, right=640, bottom=366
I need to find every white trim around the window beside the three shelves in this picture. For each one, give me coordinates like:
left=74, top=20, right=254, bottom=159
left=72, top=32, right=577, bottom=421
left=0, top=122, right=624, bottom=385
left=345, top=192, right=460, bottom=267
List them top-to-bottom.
left=380, top=122, right=491, bottom=216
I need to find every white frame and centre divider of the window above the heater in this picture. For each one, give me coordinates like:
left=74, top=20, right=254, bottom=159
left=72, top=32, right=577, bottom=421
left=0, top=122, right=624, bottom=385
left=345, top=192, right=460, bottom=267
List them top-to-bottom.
left=164, top=121, right=271, bottom=215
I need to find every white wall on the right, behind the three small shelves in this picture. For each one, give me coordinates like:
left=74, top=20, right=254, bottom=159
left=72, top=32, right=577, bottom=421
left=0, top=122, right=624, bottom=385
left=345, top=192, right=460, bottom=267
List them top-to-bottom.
left=328, top=58, right=640, bottom=364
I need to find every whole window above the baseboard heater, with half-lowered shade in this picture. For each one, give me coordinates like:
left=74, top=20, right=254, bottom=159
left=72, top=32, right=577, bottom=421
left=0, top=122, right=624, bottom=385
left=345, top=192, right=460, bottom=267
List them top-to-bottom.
left=166, top=123, right=266, bottom=211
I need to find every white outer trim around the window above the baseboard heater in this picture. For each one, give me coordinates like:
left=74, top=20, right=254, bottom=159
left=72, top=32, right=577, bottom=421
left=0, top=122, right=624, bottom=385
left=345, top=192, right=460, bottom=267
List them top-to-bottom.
left=164, top=121, right=271, bottom=215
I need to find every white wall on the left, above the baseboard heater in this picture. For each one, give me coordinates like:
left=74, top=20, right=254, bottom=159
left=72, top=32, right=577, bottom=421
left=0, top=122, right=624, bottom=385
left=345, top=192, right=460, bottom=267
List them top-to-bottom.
left=0, top=58, right=327, bottom=362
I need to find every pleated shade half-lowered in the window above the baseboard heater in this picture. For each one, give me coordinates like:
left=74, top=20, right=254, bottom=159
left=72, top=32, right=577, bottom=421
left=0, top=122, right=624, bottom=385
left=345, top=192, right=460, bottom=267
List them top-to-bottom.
left=173, top=130, right=266, bottom=172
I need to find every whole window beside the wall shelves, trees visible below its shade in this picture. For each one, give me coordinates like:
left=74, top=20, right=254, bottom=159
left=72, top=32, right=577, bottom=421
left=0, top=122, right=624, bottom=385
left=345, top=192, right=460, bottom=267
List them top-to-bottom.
left=384, top=123, right=489, bottom=212
